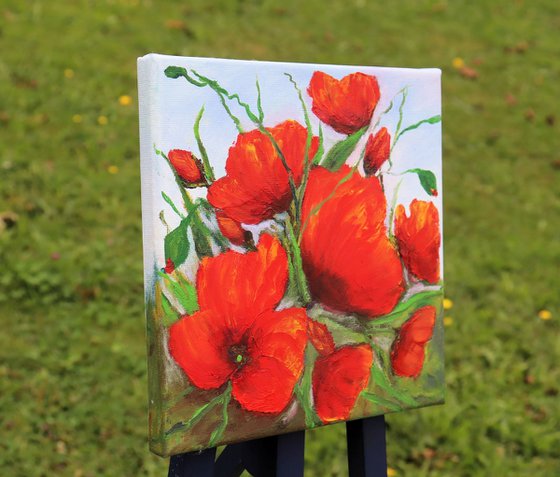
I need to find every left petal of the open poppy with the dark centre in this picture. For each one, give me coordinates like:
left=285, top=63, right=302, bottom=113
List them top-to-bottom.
left=169, top=311, right=235, bottom=389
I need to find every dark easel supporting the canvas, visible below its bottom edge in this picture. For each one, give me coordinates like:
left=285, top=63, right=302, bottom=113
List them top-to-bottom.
left=168, top=416, right=387, bottom=477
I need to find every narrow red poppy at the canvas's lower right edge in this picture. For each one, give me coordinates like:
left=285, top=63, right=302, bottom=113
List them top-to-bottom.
left=391, top=306, right=436, bottom=378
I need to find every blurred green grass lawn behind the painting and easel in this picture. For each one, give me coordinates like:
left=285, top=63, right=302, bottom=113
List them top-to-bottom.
left=0, top=0, right=560, bottom=477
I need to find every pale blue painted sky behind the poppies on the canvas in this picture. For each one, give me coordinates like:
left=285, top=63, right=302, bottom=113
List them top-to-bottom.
left=139, top=55, right=443, bottom=278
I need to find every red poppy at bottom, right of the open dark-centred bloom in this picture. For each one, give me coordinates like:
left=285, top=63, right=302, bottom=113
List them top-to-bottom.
left=313, top=344, right=373, bottom=423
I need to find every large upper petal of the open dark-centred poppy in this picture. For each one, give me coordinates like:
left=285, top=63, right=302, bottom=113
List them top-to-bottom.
left=197, top=234, right=288, bottom=322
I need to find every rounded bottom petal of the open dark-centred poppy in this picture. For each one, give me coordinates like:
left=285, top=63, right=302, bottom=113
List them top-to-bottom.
left=232, top=356, right=297, bottom=414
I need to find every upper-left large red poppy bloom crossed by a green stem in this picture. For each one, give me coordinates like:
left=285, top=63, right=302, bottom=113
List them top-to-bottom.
left=208, top=120, right=319, bottom=224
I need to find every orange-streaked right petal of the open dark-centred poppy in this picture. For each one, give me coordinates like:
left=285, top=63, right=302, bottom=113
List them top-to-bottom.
left=248, top=308, right=307, bottom=383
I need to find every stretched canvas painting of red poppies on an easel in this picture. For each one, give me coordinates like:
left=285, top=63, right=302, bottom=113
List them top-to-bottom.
left=138, top=54, right=444, bottom=455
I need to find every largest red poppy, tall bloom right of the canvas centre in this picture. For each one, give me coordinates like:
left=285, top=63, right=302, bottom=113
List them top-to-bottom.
left=301, top=166, right=404, bottom=317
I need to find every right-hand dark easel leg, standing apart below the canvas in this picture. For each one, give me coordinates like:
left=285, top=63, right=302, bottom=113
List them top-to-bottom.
left=346, top=416, right=387, bottom=477
